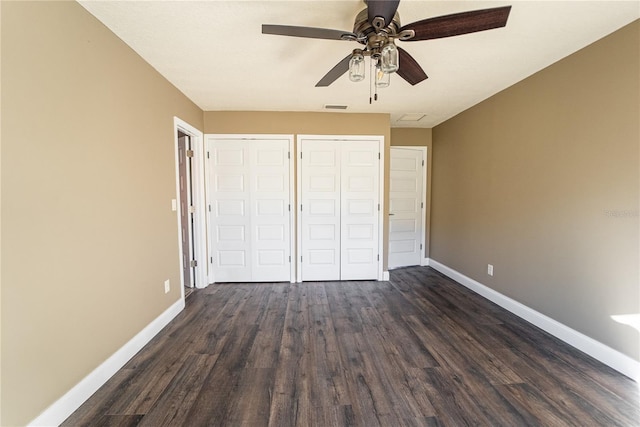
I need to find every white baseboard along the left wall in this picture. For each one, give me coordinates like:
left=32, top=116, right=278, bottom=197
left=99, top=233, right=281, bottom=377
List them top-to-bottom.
left=29, top=298, right=184, bottom=426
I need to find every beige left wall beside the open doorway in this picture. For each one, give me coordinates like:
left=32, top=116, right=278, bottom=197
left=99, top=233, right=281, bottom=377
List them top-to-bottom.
left=0, top=2, right=202, bottom=426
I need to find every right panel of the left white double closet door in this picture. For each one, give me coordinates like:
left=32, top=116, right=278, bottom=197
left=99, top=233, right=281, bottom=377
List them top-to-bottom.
left=250, top=140, right=291, bottom=282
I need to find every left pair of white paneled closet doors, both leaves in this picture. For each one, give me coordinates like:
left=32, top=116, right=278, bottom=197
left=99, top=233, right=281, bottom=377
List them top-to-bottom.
left=207, top=137, right=291, bottom=282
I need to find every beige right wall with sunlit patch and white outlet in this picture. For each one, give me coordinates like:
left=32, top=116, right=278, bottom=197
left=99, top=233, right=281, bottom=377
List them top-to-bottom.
left=431, top=21, right=640, bottom=360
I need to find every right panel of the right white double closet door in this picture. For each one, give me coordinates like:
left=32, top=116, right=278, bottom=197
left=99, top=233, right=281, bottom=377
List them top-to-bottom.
left=340, top=141, right=379, bottom=280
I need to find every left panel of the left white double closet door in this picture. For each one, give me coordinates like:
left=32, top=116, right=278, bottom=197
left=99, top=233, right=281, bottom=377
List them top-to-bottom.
left=208, top=140, right=252, bottom=282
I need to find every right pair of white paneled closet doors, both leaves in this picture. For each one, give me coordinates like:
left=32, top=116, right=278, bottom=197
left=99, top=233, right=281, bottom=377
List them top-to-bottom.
left=299, top=139, right=380, bottom=281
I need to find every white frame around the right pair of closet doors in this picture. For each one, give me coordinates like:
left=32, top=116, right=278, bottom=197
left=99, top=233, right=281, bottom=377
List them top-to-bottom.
left=295, top=135, right=388, bottom=283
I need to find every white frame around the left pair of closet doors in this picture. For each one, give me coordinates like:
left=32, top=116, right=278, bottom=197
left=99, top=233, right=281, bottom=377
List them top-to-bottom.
left=202, top=133, right=296, bottom=283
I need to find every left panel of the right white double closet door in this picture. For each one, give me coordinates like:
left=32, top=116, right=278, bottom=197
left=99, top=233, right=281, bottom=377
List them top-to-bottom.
left=299, top=140, right=340, bottom=281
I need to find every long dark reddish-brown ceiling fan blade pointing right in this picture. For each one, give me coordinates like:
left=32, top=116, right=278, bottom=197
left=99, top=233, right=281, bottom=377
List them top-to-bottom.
left=400, top=6, right=511, bottom=41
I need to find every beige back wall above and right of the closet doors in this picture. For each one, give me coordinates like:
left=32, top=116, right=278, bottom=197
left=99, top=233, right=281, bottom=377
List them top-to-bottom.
left=204, top=111, right=391, bottom=270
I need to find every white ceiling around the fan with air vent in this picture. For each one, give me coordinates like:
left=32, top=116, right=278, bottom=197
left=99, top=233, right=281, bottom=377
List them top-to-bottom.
left=80, top=0, right=640, bottom=128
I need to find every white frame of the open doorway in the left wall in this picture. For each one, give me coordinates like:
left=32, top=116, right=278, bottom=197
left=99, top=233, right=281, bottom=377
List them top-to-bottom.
left=171, top=116, right=208, bottom=299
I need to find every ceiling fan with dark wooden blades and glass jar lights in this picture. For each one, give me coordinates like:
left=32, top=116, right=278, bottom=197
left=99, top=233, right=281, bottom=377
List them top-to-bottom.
left=262, top=0, right=511, bottom=87
